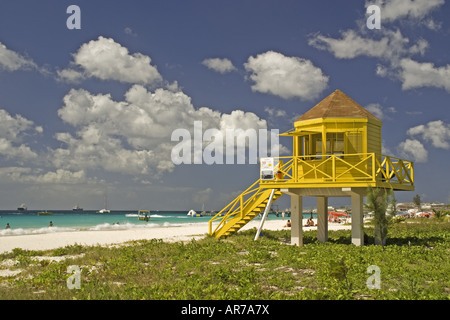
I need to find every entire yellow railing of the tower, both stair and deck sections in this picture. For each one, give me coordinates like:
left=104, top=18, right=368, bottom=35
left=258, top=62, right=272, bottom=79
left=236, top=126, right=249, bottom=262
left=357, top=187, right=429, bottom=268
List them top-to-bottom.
left=209, top=153, right=414, bottom=235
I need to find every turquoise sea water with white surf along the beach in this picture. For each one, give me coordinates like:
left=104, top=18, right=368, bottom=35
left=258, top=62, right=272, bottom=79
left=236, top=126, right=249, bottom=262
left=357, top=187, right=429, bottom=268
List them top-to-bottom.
left=0, top=210, right=298, bottom=237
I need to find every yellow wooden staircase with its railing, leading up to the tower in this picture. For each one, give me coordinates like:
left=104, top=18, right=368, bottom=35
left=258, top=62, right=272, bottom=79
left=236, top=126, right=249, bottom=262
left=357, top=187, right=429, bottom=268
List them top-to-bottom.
left=209, top=180, right=283, bottom=239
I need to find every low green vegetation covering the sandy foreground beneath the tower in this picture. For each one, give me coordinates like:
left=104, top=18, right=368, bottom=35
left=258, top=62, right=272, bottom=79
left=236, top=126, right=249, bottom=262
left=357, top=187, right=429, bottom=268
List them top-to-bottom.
left=0, top=218, right=450, bottom=299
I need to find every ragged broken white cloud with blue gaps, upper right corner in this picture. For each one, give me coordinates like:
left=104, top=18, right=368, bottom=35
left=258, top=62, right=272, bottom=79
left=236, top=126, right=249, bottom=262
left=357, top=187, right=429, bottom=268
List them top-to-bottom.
left=309, top=0, right=442, bottom=91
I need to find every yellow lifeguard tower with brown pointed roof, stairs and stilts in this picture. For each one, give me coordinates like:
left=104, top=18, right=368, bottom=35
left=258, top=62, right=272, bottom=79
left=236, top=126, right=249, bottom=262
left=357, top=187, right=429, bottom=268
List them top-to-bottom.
left=209, top=90, right=414, bottom=246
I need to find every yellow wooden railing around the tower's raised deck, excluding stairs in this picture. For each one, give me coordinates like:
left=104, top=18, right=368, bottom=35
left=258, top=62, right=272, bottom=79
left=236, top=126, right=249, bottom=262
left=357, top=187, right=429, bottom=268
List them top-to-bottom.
left=261, top=153, right=414, bottom=187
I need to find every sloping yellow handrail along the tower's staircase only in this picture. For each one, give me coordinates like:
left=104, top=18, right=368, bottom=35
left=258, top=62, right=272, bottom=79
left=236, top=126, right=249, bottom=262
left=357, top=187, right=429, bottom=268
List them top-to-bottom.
left=209, top=179, right=266, bottom=235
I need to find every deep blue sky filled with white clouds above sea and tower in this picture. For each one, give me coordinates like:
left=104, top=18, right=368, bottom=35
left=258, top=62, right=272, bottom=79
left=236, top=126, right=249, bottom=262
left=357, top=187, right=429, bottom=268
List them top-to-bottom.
left=0, top=0, right=450, bottom=210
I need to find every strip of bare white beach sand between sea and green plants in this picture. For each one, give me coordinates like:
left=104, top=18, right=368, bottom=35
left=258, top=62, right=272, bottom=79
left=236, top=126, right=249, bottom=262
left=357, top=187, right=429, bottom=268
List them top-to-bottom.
left=0, top=219, right=350, bottom=253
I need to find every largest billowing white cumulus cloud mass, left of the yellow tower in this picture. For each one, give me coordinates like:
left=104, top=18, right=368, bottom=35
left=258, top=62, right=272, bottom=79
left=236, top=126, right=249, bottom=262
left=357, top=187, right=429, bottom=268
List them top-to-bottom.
left=51, top=85, right=267, bottom=175
